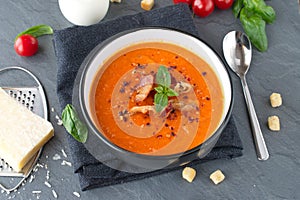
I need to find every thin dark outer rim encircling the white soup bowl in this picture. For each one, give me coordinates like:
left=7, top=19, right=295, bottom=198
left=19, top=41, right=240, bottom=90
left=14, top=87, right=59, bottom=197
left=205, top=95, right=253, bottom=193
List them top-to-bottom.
left=79, top=26, right=234, bottom=160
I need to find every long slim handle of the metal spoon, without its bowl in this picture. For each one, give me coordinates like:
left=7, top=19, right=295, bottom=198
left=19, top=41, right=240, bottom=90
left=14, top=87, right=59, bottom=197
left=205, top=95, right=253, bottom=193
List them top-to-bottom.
left=240, top=76, right=269, bottom=160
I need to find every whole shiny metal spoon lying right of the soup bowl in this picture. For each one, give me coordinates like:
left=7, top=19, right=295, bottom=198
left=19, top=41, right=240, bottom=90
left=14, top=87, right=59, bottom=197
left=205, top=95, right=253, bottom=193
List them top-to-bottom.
left=223, top=31, right=269, bottom=160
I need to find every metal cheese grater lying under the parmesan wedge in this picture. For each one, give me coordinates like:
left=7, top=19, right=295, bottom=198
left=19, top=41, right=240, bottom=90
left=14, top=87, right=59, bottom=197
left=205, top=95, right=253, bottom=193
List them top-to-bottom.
left=0, top=66, right=48, bottom=192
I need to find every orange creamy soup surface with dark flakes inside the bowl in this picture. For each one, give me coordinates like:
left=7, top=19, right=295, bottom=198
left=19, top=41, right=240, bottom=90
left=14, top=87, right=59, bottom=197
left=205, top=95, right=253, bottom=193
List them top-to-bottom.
left=90, top=42, right=223, bottom=155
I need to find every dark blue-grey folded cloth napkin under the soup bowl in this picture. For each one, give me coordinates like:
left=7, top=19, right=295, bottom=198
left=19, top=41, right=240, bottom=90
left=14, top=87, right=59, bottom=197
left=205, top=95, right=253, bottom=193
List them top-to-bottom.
left=54, top=4, right=242, bottom=190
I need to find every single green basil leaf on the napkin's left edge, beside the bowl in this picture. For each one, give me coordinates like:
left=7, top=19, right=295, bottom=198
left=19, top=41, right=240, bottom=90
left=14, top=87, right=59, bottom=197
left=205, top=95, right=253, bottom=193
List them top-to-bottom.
left=62, top=104, right=88, bottom=143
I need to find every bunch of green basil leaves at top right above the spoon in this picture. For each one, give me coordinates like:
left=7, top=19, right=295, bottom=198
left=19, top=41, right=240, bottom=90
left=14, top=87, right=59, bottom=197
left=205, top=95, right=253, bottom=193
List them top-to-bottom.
left=232, top=0, right=276, bottom=52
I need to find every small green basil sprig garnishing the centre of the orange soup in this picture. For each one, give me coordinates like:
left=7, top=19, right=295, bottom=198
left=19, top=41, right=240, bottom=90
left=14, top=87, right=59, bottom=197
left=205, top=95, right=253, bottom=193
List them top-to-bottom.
left=154, top=66, right=178, bottom=112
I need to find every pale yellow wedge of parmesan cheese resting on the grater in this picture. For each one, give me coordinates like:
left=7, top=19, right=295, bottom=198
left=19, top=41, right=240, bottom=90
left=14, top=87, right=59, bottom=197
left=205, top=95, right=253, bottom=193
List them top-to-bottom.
left=0, top=88, right=54, bottom=172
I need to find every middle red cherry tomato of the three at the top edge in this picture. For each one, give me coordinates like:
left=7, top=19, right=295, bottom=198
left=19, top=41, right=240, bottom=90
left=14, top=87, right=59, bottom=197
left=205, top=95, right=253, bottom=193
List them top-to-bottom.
left=192, top=0, right=215, bottom=17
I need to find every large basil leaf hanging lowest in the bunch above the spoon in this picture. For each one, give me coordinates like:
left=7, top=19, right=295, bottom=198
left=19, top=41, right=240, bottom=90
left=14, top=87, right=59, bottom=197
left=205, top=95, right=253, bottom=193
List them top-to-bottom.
left=240, top=8, right=268, bottom=51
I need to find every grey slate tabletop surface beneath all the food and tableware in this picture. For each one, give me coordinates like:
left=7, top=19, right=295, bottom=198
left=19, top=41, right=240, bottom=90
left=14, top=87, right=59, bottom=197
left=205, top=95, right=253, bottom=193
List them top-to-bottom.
left=0, top=0, right=300, bottom=200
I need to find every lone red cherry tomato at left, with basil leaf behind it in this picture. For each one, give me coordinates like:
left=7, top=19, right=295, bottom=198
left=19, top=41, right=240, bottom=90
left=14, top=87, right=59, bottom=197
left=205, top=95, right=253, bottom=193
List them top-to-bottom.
left=14, top=34, right=38, bottom=56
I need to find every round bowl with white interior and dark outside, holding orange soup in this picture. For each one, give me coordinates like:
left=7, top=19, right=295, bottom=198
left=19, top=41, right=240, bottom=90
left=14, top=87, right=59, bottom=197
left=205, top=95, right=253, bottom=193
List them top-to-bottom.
left=79, top=28, right=233, bottom=173
